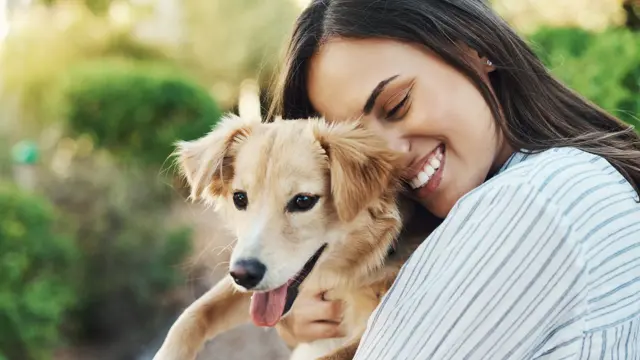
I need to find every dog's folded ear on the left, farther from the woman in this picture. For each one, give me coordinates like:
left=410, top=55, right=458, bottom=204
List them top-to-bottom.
left=175, top=115, right=259, bottom=200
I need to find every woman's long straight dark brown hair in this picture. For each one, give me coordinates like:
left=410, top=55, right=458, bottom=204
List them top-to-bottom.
left=270, top=0, right=640, bottom=194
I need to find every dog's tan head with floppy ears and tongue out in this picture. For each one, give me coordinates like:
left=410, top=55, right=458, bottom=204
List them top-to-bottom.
left=177, top=116, right=399, bottom=326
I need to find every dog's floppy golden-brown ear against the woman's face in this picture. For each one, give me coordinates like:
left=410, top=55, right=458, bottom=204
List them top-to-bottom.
left=314, top=120, right=401, bottom=222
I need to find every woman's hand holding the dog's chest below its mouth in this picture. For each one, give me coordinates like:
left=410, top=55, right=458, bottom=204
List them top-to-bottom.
left=276, top=291, right=345, bottom=348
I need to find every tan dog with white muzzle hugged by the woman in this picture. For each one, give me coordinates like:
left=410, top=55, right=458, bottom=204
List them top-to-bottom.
left=154, top=116, right=433, bottom=360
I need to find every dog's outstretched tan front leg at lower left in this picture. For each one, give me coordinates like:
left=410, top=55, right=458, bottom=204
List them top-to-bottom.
left=153, top=276, right=251, bottom=360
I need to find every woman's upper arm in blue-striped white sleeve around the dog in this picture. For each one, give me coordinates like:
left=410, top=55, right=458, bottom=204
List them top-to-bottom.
left=356, top=181, right=585, bottom=360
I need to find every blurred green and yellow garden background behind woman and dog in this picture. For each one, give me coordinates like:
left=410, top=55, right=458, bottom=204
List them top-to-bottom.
left=0, top=0, right=640, bottom=360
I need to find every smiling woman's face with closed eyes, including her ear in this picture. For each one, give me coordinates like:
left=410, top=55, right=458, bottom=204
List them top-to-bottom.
left=308, top=39, right=512, bottom=218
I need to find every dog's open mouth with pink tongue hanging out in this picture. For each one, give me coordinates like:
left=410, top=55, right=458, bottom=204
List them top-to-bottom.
left=250, top=244, right=327, bottom=327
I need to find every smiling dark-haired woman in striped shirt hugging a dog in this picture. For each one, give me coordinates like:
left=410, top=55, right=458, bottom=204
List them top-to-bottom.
left=272, top=0, right=640, bottom=360
